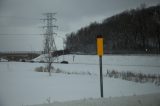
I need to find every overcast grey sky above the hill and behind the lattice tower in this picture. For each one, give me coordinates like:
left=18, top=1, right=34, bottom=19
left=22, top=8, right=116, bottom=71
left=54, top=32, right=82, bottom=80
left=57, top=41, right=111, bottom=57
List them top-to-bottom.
left=0, top=0, right=160, bottom=51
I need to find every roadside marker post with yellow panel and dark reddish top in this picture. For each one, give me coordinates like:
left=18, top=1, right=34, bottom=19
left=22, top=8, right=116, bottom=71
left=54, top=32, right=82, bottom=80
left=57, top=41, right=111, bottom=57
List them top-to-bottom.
left=97, top=35, right=103, bottom=98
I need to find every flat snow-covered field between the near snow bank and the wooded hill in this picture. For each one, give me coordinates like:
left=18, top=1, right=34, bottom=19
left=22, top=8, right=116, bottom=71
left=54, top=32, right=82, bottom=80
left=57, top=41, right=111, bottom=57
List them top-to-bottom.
left=0, top=55, right=160, bottom=106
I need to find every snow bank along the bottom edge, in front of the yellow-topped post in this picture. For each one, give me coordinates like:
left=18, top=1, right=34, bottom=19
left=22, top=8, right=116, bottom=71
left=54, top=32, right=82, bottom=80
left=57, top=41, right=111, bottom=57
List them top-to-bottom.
left=32, top=93, right=160, bottom=106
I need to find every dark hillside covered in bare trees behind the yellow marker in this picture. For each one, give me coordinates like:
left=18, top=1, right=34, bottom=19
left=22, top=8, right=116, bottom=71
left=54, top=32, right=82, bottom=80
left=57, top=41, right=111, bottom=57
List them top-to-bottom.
left=66, top=5, right=160, bottom=53
